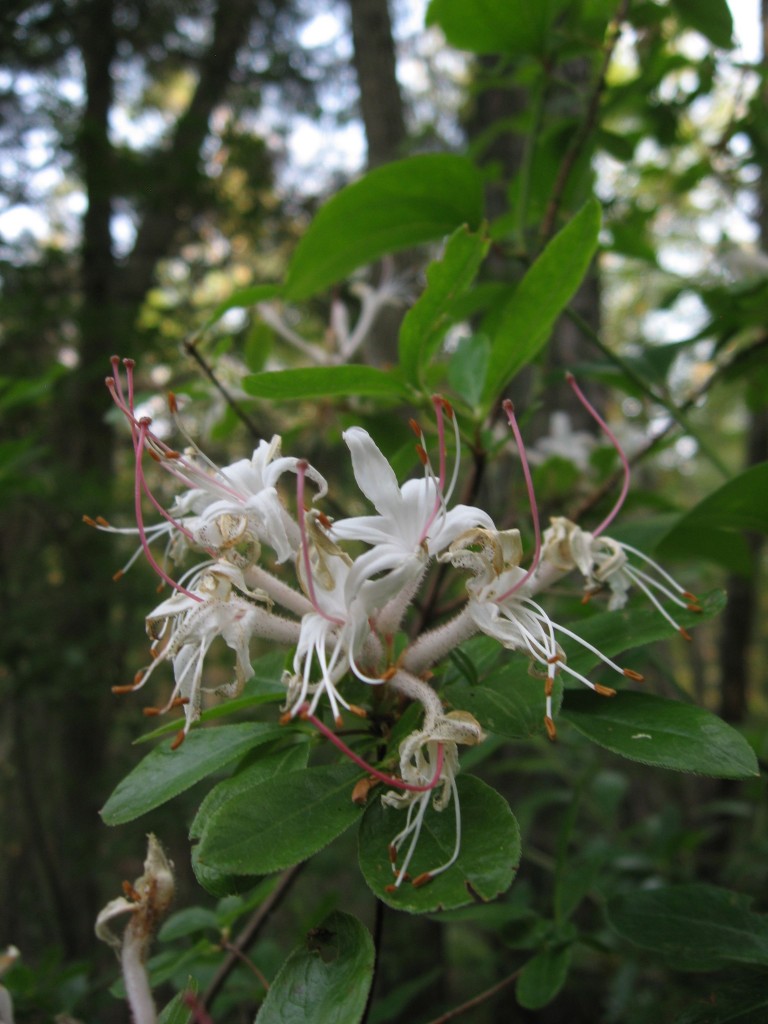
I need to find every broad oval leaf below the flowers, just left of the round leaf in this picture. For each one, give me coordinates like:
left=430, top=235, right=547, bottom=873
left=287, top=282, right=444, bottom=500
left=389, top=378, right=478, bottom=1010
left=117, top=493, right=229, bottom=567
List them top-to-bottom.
left=198, top=764, right=362, bottom=874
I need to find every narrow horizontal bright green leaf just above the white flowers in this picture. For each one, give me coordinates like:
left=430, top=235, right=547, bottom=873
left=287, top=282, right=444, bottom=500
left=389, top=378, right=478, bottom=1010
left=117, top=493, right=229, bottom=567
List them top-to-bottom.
left=243, top=364, right=408, bottom=401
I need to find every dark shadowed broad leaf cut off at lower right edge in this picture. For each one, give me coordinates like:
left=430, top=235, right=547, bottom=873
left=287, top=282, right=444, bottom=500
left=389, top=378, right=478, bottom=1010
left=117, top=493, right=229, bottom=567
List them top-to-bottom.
left=607, top=883, right=768, bottom=970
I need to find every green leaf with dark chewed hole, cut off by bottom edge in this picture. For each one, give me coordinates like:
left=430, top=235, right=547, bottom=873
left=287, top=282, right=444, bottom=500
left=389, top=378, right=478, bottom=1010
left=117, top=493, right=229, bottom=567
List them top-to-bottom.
left=256, top=910, right=376, bottom=1024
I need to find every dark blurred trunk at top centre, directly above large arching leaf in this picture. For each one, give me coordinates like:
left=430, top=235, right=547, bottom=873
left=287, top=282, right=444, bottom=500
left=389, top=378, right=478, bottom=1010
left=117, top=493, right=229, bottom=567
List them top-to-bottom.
left=349, top=0, right=407, bottom=167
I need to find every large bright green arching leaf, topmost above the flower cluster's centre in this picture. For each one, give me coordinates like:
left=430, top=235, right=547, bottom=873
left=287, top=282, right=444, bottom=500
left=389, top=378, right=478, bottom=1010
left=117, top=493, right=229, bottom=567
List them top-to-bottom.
left=285, top=154, right=483, bottom=299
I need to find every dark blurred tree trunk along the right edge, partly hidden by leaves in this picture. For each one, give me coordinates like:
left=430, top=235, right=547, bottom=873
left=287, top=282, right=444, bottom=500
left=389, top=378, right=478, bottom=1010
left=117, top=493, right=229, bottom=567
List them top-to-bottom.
left=720, top=0, right=768, bottom=722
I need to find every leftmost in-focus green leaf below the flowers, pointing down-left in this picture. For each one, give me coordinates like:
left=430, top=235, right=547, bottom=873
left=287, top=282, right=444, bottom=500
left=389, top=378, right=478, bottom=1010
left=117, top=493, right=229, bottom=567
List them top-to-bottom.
left=101, top=722, right=285, bottom=825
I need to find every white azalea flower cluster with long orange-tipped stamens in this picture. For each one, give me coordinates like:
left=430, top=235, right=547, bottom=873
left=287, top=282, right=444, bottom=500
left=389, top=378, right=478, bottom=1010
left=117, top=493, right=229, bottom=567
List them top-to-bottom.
left=88, top=358, right=694, bottom=885
